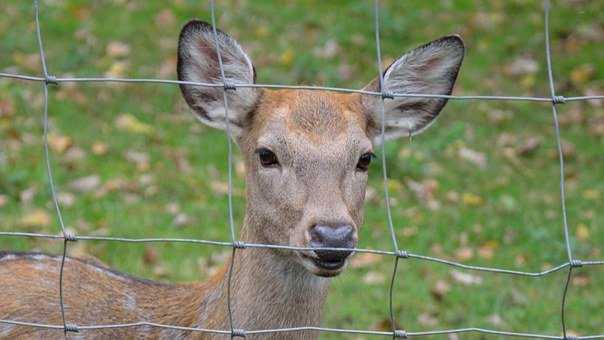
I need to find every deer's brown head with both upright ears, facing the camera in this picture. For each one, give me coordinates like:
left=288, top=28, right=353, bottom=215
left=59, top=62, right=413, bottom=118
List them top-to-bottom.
left=178, top=21, right=464, bottom=276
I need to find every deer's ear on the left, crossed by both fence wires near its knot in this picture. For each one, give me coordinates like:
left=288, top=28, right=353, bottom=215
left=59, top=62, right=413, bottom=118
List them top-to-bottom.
left=177, top=20, right=259, bottom=136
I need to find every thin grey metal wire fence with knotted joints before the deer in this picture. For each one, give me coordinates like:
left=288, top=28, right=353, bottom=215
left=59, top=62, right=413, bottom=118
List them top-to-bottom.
left=0, top=0, right=604, bottom=339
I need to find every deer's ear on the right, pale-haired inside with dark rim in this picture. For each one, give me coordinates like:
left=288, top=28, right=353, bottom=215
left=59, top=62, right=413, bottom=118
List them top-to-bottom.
left=361, top=36, right=464, bottom=141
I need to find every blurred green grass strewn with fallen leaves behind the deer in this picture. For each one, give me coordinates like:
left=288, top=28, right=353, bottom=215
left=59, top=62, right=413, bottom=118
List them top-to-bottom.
left=0, top=0, right=604, bottom=339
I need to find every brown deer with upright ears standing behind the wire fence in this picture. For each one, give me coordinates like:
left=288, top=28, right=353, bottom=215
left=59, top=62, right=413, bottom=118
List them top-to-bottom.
left=0, top=20, right=465, bottom=340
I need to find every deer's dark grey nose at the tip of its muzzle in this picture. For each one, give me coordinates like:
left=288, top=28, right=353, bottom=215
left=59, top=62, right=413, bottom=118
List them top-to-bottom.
left=310, top=224, right=354, bottom=263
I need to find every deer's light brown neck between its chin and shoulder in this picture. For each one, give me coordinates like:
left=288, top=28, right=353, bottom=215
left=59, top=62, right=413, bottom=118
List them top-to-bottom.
left=199, top=218, right=329, bottom=339
